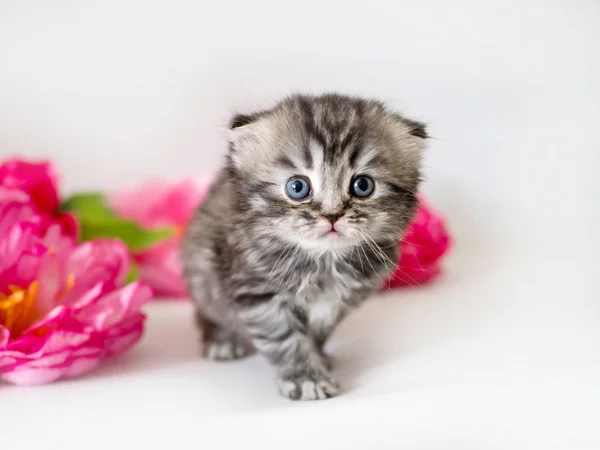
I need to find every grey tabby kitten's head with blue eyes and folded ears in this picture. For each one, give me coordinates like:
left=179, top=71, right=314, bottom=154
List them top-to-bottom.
left=228, top=95, right=427, bottom=253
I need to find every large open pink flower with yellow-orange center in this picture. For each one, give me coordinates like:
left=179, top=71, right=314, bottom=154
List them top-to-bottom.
left=0, top=197, right=151, bottom=385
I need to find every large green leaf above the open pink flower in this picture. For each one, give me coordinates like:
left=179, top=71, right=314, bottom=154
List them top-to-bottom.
left=61, top=193, right=174, bottom=252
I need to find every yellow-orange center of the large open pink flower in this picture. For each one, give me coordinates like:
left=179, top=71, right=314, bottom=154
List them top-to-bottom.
left=0, top=275, right=75, bottom=339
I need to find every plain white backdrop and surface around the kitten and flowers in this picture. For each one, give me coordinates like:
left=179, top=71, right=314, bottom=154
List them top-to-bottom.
left=0, top=0, right=600, bottom=450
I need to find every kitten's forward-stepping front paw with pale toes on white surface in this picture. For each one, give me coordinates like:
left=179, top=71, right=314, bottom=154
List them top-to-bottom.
left=277, top=373, right=340, bottom=400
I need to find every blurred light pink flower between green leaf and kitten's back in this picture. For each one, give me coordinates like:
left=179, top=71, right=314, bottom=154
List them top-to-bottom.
left=109, top=179, right=210, bottom=297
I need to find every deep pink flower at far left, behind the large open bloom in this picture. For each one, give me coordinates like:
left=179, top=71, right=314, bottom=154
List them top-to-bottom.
left=0, top=158, right=78, bottom=236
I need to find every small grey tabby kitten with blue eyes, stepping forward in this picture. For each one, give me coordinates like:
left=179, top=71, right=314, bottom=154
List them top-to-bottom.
left=182, top=94, right=427, bottom=400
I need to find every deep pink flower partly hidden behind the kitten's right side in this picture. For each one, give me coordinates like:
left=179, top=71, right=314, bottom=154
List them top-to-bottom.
left=384, top=196, right=451, bottom=288
